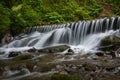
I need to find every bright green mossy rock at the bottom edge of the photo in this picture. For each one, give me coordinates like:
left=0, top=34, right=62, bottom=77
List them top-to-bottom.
left=51, top=73, right=82, bottom=80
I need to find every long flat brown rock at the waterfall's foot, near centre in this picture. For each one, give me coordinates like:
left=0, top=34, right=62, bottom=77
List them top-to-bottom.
left=38, top=45, right=70, bottom=53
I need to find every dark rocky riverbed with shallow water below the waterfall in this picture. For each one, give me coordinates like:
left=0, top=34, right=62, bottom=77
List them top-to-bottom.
left=0, top=36, right=120, bottom=80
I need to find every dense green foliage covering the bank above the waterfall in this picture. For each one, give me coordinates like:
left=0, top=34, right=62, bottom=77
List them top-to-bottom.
left=0, top=0, right=120, bottom=33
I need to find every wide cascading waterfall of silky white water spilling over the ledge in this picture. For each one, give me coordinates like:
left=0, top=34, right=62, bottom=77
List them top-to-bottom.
left=0, top=17, right=120, bottom=52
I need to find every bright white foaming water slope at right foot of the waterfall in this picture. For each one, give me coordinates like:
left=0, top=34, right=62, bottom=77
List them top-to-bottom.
left=71, top=30, right=119, bottom=54
